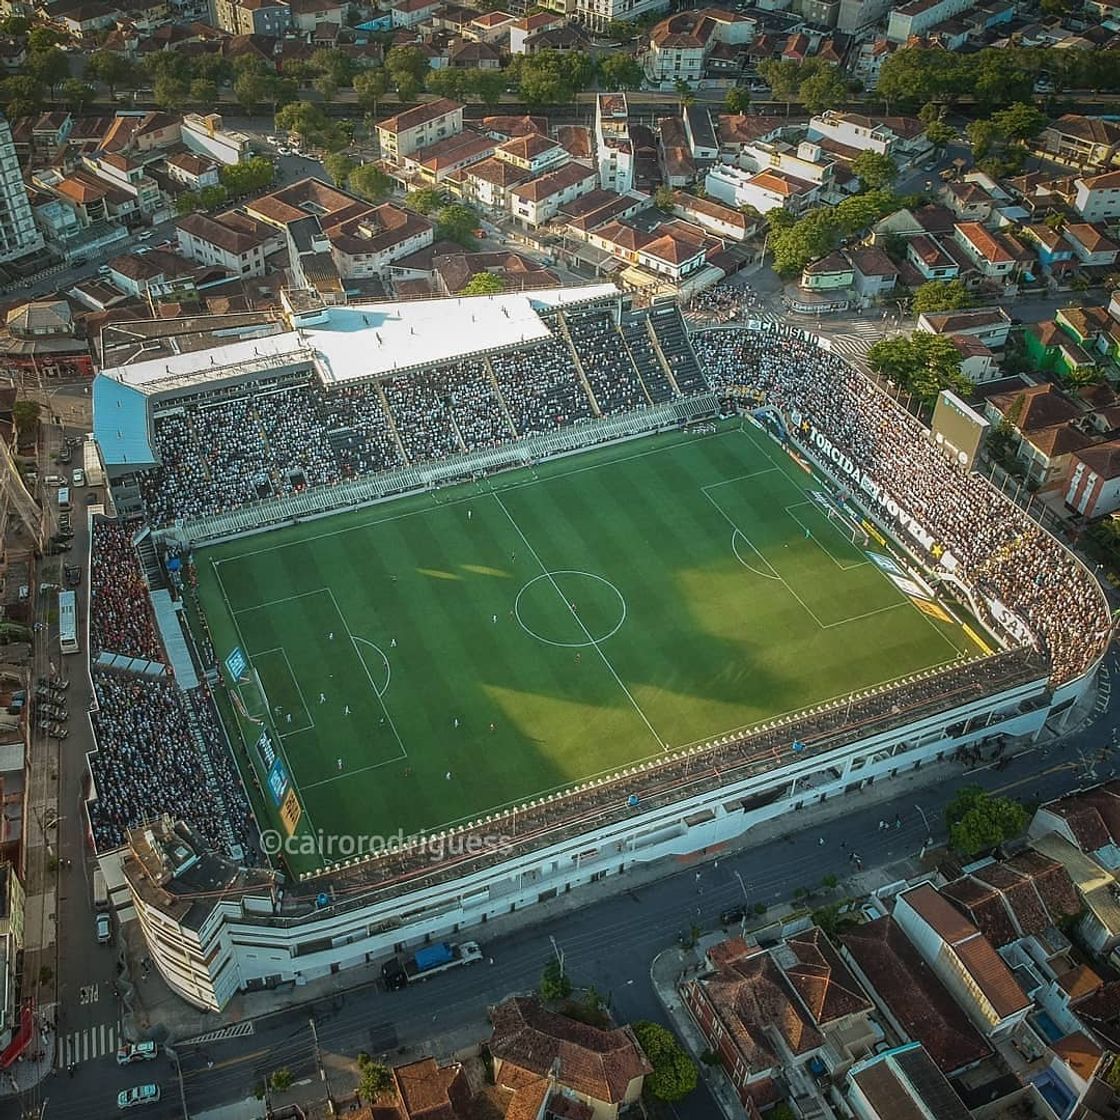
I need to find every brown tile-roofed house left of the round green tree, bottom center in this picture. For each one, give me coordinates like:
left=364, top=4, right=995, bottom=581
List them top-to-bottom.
left=488, top=996, right=653, bottom=1120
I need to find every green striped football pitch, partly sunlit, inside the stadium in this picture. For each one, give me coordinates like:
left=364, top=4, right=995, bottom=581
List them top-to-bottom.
left=196, top=421, right=977, bottom=871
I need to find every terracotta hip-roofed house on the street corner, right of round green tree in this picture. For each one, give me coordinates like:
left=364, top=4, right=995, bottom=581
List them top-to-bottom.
left=680, top=926, right=877, bottom=1116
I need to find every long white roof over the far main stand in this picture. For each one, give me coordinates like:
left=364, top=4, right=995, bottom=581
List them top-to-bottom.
left=94, top=283, right=618, bottom=395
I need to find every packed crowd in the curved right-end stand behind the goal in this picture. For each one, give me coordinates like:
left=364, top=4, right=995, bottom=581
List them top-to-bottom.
left=693, top=330, right=1110, bottom=683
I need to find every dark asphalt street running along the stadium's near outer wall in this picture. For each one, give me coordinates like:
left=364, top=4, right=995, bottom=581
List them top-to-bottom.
left=13, top=655, right=1120, bottom=1120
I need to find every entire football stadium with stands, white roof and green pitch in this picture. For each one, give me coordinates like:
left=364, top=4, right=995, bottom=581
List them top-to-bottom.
left=88, top=284, right=1111, bottom=1008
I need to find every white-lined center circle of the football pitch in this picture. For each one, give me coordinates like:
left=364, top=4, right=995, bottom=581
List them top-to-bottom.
left=513, top=570, right=626, bottom=650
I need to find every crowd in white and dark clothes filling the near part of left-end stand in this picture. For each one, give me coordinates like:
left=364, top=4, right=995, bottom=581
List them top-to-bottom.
left=90, top=671, right=244, bottom=851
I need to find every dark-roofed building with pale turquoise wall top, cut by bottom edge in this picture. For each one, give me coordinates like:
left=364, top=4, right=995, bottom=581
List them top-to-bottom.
left=846, top=1043, right=972, bottom=1120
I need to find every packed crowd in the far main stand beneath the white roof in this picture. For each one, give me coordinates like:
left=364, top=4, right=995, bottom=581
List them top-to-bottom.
left=141, top=297, right=707, bottom=524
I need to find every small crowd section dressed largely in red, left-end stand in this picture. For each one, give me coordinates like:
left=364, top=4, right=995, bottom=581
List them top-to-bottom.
left=90, top=521, right=164, bottom=661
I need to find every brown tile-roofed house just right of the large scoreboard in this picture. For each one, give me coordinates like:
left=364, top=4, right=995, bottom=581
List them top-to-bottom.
left=984, top=383, right=1093, bottom=486
